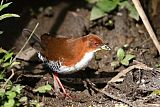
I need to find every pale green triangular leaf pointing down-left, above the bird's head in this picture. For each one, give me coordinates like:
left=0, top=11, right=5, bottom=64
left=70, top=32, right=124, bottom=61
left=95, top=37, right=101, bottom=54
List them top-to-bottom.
left=90, top=6, right=106, bottom=20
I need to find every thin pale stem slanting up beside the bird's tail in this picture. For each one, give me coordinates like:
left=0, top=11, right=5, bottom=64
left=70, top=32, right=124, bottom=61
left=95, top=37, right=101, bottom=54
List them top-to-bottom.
left=12, top=23, right=39, bottom=62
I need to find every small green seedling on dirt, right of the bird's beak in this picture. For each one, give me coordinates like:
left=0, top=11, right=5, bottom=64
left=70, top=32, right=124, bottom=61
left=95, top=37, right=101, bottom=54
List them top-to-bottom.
left=111, top=48, right=135, bottom=68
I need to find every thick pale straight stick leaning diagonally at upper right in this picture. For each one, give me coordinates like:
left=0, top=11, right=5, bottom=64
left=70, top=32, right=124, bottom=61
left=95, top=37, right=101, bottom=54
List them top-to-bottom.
left=132, top=0, right=160, bottom=54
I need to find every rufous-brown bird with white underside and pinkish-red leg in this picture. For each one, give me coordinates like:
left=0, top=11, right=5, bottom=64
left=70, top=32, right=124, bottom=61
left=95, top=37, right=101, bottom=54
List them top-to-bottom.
left=22, top=29, right=111, bottom=96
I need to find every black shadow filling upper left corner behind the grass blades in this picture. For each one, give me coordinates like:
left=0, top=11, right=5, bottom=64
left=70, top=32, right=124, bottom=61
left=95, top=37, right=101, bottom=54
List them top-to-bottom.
left=0, top=0, right=56, bottom=49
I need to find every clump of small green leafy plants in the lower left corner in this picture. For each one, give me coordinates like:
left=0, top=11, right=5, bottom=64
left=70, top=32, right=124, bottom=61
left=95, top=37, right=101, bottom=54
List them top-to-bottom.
left=0, top=48, right=24, bottom=107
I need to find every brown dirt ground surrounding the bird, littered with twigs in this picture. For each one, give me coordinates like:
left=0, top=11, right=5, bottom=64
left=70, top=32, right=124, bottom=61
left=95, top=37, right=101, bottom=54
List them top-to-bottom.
left=0, top=0, right=160, bottom=107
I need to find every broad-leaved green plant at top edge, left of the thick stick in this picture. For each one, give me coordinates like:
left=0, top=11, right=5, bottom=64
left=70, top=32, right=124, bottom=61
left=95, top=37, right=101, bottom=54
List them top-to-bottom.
left=87, top=0, right=139, bottom=20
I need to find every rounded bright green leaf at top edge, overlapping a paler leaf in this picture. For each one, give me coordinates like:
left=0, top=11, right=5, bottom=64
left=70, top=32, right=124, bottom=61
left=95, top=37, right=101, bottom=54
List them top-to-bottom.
left=96, top=0, right=120, bottom=12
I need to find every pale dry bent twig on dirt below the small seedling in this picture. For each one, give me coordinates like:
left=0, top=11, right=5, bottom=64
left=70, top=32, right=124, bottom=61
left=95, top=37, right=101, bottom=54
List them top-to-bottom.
left=108, top=61, right=153, bottom=83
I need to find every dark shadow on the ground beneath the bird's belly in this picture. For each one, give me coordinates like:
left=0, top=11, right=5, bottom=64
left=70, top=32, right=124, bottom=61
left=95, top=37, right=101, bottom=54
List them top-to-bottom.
left=59, top=68, right=117, bottom=91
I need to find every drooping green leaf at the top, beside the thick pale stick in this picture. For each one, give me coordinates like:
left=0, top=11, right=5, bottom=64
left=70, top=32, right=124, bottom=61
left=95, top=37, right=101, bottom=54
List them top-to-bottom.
left=119, top=1, right=139, bottom=21
